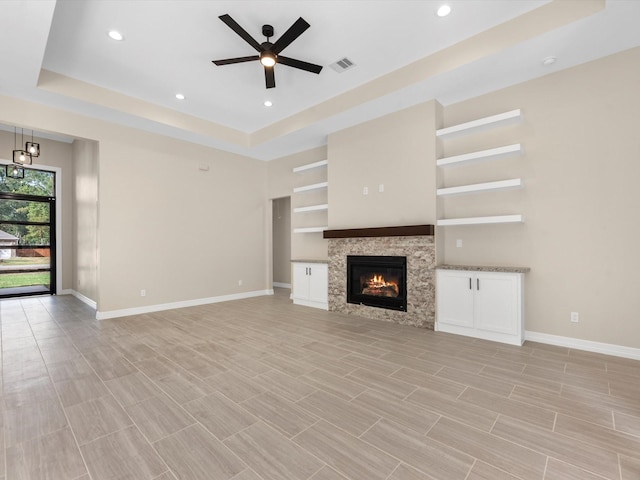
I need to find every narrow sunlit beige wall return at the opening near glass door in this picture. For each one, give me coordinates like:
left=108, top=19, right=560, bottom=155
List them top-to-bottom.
left=73, top=140, right=99, bottom=302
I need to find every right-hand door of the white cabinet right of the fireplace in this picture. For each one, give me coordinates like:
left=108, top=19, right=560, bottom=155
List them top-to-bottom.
left=473, top=273, right=521, bottom=335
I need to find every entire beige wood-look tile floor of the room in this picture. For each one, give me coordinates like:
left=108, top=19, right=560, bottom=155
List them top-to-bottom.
left=0, top=291, right=640, bottom=480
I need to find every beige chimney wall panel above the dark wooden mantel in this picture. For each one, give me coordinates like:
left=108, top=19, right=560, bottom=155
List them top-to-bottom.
left=328, top=101, right=438, bottom=229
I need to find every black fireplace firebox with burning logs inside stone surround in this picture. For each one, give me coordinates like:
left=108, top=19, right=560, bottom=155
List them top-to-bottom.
left=347, top=255, right=407, bottom=312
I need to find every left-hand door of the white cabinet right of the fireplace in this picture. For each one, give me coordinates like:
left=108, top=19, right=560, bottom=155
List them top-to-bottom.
left=436, top=270, right=474, bottom=328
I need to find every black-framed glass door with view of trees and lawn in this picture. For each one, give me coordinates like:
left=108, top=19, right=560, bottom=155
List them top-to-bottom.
left=0, top=166, right=56, bottom=298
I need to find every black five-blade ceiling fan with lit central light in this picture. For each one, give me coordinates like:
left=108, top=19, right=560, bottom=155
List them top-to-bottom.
left=212, top=14, right=322, bottom=88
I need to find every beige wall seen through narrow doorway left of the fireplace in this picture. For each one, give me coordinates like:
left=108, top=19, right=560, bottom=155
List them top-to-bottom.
left=272, top=197, right=291, bottom=284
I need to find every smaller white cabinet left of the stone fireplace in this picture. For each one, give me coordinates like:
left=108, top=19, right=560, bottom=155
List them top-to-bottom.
left=292, top=262, right=329, bottom=310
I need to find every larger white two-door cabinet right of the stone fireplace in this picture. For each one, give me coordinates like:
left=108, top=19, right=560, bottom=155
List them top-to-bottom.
left=436, top=270, right=524, bottom=345
